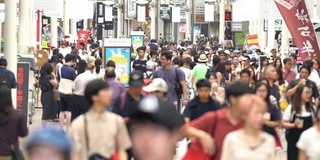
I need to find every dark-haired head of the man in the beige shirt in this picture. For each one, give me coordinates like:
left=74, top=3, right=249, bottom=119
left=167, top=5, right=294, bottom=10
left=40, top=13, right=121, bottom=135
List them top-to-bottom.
left=84, top=79, right=112, bottom=106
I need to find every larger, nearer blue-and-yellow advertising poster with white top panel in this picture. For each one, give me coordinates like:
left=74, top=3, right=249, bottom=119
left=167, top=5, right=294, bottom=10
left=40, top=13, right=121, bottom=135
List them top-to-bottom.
left=104, top=38, right=131, bottom=87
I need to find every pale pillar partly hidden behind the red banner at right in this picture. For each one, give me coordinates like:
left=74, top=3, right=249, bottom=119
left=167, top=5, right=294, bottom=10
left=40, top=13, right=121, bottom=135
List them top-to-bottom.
left=281, top=21, right=289, bottom=59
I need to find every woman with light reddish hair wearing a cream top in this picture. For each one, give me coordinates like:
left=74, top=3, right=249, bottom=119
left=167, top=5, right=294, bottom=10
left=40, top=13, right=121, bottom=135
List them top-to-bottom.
left=221, top=96, right=275, bottom=160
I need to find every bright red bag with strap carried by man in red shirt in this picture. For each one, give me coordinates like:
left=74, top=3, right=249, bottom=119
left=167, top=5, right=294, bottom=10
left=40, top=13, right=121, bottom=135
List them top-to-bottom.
left=182, top=113, right=218, bottom=160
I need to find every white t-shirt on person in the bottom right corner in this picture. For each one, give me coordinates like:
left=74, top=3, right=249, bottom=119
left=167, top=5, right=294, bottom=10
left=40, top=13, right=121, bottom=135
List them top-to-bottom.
left=297, top=127, right=320, bottom=160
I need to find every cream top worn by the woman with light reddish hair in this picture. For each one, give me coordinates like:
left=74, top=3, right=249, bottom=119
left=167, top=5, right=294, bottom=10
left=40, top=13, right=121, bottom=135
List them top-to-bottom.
left=221, top=130, right=276, bottom=160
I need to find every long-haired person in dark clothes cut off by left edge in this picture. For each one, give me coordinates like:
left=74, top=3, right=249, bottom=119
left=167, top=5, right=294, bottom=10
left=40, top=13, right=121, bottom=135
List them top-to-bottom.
left=0, top=85, right=28, bottom=160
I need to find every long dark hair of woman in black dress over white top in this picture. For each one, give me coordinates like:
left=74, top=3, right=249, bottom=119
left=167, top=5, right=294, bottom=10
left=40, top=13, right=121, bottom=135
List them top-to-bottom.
left=291, top=85, right=312, bottom=114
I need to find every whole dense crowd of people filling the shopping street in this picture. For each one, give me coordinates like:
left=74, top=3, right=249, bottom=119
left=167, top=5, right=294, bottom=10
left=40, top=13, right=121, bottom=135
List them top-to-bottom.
left=0, top=40, right=320, bottom=160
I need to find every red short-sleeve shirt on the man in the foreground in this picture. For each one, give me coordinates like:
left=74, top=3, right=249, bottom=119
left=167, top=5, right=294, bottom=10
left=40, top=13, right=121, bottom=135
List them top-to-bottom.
left=182, top=108, right=243, bottom=159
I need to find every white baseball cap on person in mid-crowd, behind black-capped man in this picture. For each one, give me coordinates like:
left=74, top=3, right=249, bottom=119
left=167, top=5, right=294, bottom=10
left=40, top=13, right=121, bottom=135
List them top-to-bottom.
left=143, top=78, right=168, bottom=93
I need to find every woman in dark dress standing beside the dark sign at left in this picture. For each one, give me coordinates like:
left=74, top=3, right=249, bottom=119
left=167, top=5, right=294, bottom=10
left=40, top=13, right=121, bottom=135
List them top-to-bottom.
left=40, top=63, right=58, bottom=127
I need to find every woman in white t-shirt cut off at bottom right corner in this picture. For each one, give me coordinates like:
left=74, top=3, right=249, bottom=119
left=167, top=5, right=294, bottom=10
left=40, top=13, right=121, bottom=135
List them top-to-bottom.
left=297, top=106, right=320, bottom=160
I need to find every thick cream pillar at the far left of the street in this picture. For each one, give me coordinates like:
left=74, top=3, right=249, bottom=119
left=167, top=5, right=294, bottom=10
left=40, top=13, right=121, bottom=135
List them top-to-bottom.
left=4, top=0, right=17, bottom=108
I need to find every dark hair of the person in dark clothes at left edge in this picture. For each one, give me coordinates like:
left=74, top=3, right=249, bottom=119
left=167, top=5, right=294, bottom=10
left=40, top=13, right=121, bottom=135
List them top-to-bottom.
left=0, top=85, right=13, bottom=126
